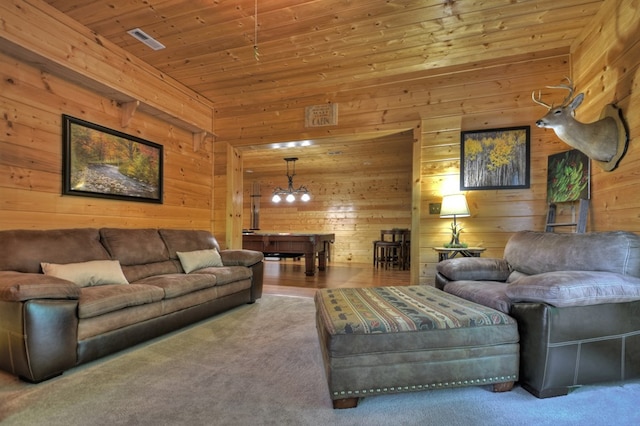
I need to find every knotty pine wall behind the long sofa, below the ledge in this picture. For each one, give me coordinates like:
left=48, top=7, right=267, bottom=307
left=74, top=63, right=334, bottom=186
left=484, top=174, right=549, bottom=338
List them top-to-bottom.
left=0, top=53, right=213, bottom=230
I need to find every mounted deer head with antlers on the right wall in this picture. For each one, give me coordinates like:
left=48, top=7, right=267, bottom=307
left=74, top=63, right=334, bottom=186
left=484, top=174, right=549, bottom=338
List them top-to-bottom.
left=531, top=77, right=627, bottom=171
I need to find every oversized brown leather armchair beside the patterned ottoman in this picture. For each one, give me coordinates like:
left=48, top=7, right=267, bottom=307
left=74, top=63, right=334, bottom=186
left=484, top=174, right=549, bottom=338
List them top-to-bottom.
left=436, top=231, right=640, bottom=398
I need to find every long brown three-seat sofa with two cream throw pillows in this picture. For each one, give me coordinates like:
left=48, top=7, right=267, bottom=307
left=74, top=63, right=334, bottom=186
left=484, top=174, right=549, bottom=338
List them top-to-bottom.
left=0, top=228, right=263, bottom=382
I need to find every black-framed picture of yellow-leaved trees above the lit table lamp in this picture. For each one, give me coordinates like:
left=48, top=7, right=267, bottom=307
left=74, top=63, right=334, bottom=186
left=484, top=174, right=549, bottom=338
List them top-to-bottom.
left=460, top=126, right=531, bottom=190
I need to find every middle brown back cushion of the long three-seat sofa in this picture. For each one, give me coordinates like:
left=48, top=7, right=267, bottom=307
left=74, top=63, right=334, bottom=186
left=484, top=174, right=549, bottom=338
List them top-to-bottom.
left=100, top=228, right=169, bottom=266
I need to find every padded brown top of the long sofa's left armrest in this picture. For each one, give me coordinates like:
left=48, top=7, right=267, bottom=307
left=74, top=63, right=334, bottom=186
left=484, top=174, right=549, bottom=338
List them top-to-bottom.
left=0, top=271, right=80, bottom=302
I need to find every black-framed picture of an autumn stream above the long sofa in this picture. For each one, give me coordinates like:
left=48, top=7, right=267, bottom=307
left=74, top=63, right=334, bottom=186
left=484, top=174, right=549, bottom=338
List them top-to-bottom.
left=62, top=115, right=164, bottom=204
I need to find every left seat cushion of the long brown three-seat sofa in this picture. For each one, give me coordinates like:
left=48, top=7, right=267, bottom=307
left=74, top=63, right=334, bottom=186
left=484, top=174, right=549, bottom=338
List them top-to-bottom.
left=78, top=284, right=164, bottom=318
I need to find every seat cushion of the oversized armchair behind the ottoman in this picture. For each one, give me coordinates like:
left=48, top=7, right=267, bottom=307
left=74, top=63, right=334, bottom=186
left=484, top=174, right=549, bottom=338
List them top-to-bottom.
left=444, top=281, right=511, bottom=314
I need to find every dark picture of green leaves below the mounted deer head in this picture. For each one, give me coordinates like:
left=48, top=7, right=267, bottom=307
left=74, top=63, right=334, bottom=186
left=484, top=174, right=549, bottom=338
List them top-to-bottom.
left=547, top=149, right=591, bottom=203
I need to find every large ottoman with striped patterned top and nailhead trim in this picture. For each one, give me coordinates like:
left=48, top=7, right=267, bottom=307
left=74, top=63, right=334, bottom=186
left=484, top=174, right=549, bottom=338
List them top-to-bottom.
left=315, top=286, right=519, bottom=408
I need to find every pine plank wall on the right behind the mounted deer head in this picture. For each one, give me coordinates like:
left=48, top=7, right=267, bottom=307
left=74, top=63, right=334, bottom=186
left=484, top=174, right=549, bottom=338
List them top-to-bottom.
left=572, top=0, right=640, bottom=232
